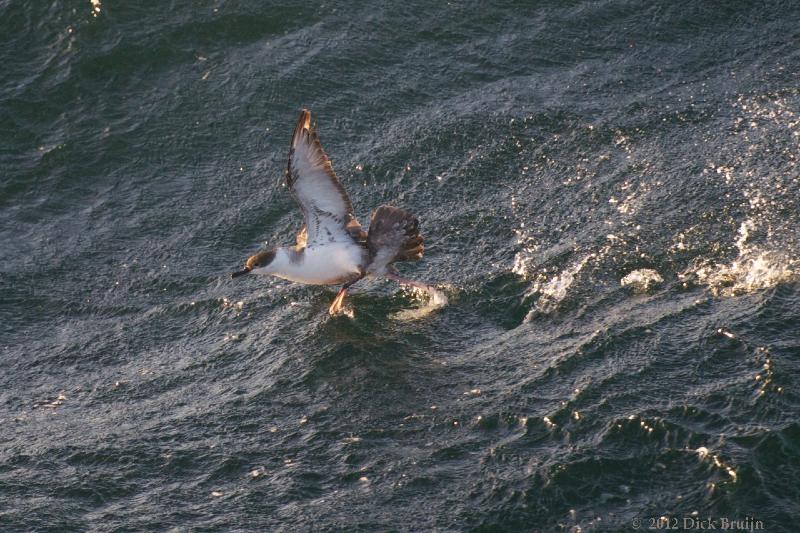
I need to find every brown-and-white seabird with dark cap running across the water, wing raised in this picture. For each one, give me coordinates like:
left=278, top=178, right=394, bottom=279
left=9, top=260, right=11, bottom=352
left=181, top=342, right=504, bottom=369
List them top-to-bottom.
left=231, top=109, right=435, bottom=315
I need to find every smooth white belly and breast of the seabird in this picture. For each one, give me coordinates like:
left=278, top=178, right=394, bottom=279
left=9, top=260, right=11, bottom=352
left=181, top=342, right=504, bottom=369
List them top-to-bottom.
left=277, top=243, right=365, bottom=285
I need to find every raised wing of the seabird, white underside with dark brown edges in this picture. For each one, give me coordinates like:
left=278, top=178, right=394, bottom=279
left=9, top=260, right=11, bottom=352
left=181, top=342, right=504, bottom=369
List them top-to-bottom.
left=286, top=109, right=366, bottom=246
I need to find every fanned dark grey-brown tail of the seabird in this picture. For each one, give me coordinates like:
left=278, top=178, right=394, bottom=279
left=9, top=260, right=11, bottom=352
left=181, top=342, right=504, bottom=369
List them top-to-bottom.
left=367, top=205, right=425, bottom=272
